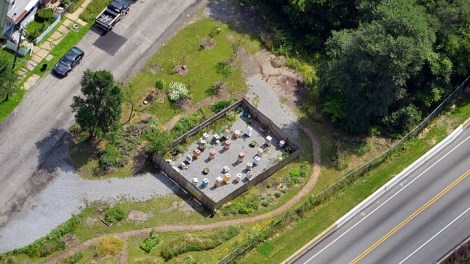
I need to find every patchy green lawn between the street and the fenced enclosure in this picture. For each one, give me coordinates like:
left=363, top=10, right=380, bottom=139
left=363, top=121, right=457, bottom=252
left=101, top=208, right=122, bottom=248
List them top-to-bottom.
left=123, top=19, right=256, bottom=123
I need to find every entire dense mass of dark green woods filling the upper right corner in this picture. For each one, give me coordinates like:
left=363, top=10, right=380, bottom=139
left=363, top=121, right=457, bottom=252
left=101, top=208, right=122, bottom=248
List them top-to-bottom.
left=250, top=0, right=470, bottom=135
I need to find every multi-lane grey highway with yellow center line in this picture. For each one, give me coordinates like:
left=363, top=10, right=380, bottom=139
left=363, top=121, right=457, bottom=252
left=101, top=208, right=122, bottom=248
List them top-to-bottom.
left=295, top=129, right=470, bottom=263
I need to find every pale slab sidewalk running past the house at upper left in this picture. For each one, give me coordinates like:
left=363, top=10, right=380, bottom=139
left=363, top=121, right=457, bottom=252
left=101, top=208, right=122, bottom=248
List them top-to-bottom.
left=18, top=0, right=91, bottom=91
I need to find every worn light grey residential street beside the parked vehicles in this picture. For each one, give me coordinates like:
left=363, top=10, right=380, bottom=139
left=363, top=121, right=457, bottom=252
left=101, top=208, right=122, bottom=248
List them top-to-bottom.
left=0, top=0, right=201, bottom=226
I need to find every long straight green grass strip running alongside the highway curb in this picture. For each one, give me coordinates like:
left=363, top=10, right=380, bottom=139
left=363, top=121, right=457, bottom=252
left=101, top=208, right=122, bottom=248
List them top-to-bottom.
left=238, top=95, right=470, bottom=263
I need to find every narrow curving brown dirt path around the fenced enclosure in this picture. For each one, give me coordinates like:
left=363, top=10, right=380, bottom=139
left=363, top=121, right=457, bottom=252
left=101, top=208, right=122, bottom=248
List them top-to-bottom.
left=46, top=127, right=321, bottom=263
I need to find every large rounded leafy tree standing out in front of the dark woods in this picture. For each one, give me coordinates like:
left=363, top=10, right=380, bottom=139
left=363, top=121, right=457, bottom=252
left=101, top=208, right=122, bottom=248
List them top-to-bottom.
left=320, top=0, right=435, bottom=133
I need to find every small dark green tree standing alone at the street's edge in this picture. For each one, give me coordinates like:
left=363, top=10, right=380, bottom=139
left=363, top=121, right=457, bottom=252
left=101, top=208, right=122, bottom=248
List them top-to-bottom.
left=72, top=70, right=123, bottom=138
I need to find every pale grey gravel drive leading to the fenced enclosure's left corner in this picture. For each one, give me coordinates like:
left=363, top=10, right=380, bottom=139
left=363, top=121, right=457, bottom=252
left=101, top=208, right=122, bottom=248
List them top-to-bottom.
left=0, top=140, right=175, bottom=252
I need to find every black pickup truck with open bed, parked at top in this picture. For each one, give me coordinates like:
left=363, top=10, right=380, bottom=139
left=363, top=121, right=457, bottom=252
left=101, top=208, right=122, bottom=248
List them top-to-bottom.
left=95, top=0, right=131, bottom=31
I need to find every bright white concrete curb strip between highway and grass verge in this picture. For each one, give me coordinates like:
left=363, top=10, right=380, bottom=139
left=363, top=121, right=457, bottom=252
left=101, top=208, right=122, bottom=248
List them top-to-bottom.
left=336, top=124, right=464, bottom=228
